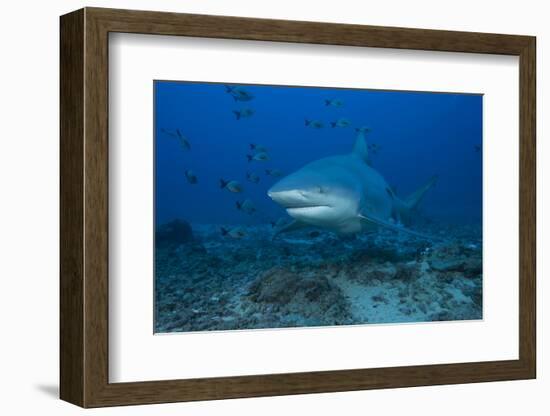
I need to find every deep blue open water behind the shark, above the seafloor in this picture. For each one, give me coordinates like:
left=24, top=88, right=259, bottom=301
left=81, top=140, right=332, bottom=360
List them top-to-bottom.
left=155, top=81, right=482, bottom=228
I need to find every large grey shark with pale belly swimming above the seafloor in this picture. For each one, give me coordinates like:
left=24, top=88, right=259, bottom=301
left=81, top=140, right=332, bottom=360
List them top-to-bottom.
left=267, top=131, right=437, bottom=238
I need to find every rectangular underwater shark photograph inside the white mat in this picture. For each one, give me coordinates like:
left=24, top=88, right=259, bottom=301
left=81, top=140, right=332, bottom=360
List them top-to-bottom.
left=152, top=80, right=483, bottom=333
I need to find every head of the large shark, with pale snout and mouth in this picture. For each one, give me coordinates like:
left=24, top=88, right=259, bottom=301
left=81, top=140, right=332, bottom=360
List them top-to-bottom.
left=267, top=160, right=360, bottom=228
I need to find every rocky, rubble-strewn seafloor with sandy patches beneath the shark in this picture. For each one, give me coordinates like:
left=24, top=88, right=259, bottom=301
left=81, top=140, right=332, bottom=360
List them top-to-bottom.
left=155, top=223, right=482, bottom=333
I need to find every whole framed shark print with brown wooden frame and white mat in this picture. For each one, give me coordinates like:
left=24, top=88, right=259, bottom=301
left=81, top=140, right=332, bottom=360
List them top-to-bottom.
left=60, top=8, right=536, bottom=407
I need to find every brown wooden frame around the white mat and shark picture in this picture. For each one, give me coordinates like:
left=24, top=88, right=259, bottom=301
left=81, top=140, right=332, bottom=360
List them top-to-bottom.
left=60, top=8, right=536, bottom=407
